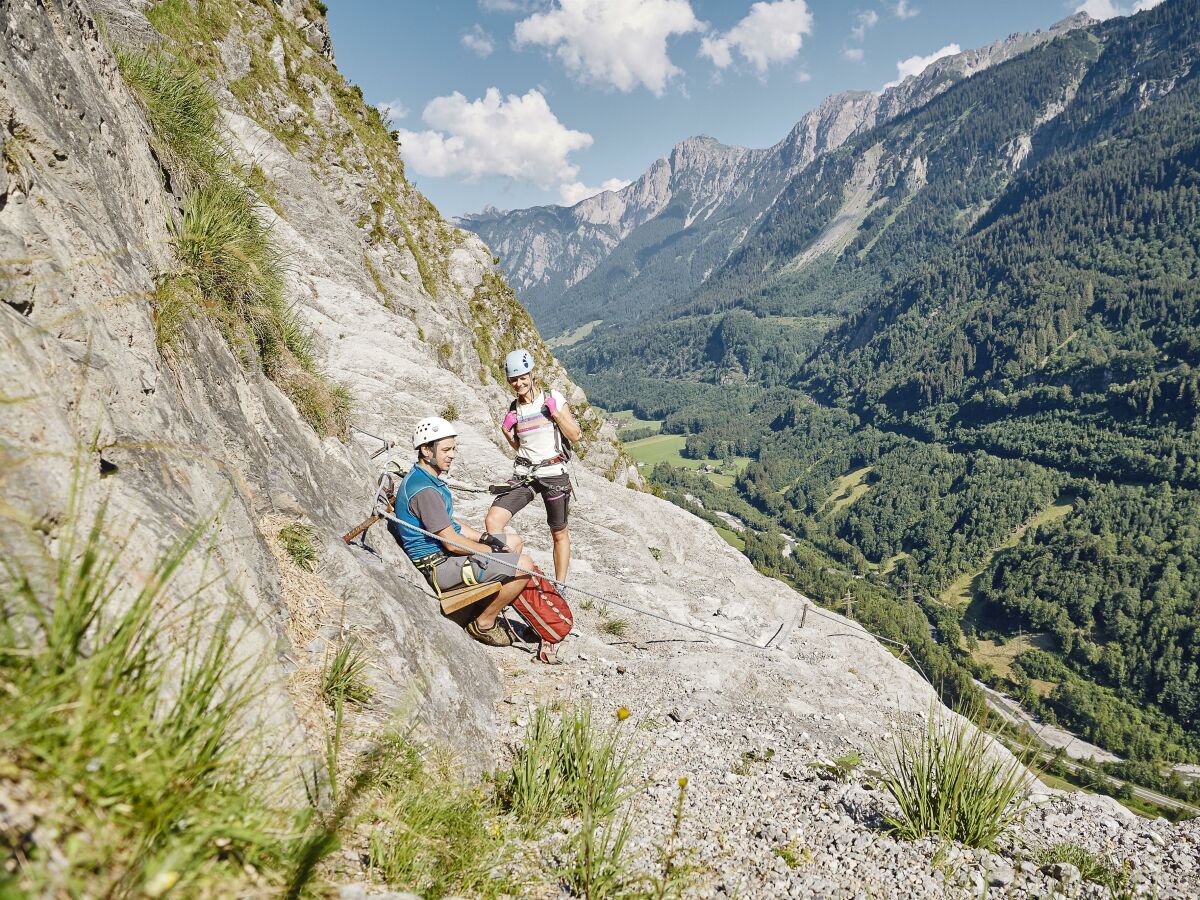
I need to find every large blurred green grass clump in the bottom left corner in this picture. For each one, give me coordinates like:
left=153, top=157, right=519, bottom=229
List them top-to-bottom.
left=0, top=482, right=304, bottom=896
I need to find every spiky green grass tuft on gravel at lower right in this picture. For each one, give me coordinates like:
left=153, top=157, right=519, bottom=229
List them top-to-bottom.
left=880, top=710, right=1028, bottom=847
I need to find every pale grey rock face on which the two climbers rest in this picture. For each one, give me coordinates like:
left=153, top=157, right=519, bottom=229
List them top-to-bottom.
left=0, top=0, right=1190, bottom=895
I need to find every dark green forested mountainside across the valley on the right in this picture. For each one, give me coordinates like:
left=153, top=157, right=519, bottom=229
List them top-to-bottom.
left=547, top=0, right=1200, bottom=777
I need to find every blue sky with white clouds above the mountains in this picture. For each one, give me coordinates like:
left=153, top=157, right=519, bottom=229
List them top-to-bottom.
left=329, top=0, right=1151, bottom=216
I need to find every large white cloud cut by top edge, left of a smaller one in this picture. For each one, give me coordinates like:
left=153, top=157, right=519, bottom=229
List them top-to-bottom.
left=514, top=0, right=703, bottom=95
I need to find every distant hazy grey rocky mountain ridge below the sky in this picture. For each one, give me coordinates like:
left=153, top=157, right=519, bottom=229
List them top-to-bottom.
left=457, top=13, right=1092, bottom=335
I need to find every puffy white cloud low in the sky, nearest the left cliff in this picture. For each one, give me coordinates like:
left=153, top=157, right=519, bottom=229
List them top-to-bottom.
left=400, top=88, right=592, bottom=188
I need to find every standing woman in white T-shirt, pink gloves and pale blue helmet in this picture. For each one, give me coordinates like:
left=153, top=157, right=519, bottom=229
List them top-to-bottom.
left=484, top=348, right=582, bottom=586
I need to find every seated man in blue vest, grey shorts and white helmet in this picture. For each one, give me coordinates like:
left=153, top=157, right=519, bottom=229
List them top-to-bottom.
left=388, top=416, right=533, bottom=647
